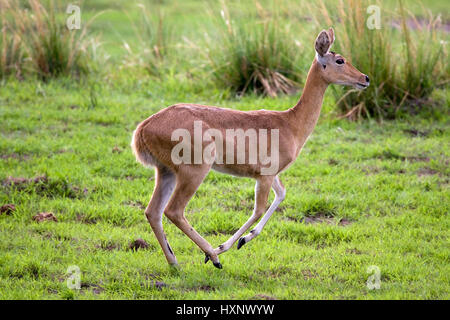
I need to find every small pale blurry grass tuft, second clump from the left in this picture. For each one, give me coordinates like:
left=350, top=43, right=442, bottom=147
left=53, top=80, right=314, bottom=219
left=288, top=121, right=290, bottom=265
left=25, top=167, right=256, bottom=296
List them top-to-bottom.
left=124, top=3, right=174, bottom=77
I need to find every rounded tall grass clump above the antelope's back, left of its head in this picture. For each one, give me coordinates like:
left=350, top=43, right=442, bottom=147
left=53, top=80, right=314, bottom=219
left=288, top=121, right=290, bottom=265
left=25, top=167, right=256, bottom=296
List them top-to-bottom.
left=206, top=2, right=302, bottom=97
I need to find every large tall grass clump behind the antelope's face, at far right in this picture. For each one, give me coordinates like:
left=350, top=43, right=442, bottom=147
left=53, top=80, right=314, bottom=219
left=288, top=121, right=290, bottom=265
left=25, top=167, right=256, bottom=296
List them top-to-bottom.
left=317, top=0, right=446, bottom=119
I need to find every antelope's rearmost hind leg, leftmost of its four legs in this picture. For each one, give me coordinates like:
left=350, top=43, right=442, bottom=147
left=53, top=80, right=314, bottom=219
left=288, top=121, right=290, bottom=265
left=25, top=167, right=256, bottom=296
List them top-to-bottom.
left=145, top=168, right=178, bottom=265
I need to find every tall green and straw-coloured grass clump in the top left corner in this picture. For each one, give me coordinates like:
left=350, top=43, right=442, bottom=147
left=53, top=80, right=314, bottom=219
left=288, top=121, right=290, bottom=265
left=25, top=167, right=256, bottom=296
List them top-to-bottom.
left=1, top=0, right=96, bottom=80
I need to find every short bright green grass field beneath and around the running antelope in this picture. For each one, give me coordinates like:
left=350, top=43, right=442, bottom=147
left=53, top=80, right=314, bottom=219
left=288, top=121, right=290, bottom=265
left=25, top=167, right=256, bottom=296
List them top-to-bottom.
left=0, top=0, right=450, bottom=299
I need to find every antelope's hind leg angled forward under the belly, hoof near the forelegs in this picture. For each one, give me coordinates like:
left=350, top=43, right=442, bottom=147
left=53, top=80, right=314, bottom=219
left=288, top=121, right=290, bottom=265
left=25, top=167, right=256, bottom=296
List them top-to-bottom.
left=164, top=164, right=222, bottom=269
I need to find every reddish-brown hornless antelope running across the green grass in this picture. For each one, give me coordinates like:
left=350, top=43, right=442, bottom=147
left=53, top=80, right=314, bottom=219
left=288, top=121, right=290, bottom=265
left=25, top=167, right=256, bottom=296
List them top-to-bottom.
left=131, top=28, right=369, bottom=268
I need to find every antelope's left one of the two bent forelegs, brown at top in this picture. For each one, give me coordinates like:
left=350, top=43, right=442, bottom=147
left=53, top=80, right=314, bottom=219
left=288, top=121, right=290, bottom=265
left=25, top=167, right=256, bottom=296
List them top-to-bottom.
left=215, top=176, right=274, bottom=254
